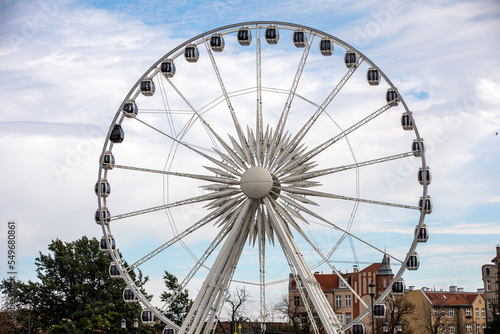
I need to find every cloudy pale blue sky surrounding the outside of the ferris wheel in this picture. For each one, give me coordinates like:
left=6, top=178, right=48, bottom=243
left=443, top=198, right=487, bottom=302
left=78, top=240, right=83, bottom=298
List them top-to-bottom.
left=0, top=0, right=500, bottom=318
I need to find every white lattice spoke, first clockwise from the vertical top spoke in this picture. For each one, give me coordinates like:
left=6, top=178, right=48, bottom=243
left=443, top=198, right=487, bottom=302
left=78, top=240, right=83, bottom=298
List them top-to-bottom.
left=267, top=33, right=314, bottom=167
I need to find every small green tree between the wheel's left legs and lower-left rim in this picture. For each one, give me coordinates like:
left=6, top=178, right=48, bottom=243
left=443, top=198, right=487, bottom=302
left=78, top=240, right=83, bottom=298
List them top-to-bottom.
left=160, top=271, right=193, bottom=325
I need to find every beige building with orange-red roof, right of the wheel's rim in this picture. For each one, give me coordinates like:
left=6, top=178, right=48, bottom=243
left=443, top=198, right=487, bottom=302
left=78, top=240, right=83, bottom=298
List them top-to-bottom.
left=405, top=286, right=486, bottom=334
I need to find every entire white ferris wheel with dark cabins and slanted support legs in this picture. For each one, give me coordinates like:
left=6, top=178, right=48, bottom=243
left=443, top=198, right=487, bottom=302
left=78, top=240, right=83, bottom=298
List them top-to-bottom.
left=95, top=21, right=432, bottom=334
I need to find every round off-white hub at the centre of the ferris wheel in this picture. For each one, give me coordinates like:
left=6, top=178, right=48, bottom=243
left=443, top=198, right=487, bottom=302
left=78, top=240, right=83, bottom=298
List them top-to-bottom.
left=240, top=166, right=273, bottom=199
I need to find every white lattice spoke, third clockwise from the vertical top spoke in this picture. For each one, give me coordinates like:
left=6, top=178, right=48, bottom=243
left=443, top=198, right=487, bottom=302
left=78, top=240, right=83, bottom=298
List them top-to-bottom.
left=275, top=104, right=392, bottom=178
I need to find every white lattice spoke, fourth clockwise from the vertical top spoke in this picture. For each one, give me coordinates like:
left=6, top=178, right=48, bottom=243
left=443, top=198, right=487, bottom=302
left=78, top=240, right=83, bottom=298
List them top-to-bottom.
left=280, top=152, right=413, bottom=183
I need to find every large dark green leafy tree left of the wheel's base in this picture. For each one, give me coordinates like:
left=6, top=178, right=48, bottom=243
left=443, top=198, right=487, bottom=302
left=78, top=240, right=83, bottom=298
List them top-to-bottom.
left=0, top=237, right=161, bottom=334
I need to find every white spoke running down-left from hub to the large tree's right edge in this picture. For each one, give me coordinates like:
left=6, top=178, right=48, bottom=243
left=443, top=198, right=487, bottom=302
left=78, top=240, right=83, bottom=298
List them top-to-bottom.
left=125, top=198, right=241, bottom=272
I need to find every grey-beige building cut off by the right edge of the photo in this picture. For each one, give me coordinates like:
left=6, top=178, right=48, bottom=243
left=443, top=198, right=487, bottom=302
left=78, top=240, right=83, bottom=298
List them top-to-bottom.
left=481, top=245, right=500, bottom=322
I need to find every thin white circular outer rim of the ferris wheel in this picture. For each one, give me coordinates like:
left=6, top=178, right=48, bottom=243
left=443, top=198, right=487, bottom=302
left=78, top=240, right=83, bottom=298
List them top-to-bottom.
left=98, top=21, right=428, bottom=330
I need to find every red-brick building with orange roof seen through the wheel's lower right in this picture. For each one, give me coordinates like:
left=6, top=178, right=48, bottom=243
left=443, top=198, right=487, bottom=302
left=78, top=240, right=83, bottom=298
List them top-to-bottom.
left=288, top=255, right=394, bottom=326
